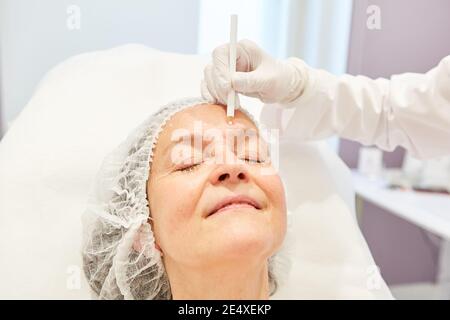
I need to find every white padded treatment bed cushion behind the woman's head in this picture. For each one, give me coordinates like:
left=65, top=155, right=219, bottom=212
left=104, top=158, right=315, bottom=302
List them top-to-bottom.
left=0, top=45, right=391, bottom=299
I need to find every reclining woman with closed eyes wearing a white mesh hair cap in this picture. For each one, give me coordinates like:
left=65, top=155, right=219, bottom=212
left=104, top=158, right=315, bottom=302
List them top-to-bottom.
left=83, top=99, right=286, bottom=299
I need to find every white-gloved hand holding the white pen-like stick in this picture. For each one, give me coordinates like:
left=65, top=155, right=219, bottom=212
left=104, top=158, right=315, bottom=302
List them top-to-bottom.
left=201, top=40, right=307, bottom=105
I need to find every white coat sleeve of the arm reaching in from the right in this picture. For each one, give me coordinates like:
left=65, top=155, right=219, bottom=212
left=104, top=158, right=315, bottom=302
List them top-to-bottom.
left=282, top=56, right=450, bottom=158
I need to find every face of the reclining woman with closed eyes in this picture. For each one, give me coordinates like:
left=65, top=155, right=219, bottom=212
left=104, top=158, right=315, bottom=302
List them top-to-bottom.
left=147, top=104, right=286, bottom=267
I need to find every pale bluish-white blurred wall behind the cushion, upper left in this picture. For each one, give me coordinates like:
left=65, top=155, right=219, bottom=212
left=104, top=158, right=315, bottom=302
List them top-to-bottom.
left=0, top=0, right=199, bottom=135
